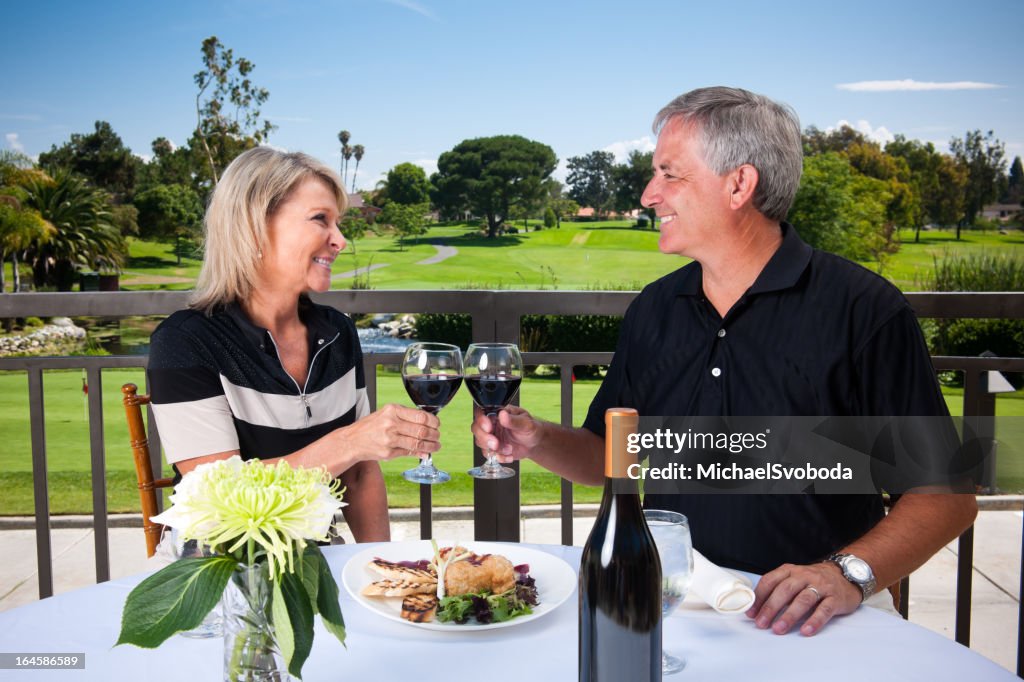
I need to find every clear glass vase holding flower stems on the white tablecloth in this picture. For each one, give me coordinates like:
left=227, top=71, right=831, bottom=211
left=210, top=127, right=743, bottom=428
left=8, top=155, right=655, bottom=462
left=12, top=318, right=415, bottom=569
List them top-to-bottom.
left=223, top=563, right=291, bottom=682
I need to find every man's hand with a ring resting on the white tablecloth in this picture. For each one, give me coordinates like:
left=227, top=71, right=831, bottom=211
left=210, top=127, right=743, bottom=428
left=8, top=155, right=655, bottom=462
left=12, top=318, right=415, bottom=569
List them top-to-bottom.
left=746, top=562, right=862, bottom=636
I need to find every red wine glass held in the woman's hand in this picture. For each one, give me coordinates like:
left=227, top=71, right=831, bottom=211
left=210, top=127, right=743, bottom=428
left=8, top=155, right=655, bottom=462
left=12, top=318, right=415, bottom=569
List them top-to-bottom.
left=401, top=343, right=462, bottom=484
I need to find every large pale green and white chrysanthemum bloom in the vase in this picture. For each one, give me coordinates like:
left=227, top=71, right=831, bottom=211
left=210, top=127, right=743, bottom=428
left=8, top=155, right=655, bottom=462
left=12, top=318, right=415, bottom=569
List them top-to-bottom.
left=154, top=456, right=344, bottom=579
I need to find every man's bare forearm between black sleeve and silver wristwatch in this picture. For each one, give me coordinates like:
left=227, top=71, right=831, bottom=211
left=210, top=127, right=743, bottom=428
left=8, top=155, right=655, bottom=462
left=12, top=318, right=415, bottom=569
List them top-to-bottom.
left=843, top=493, right=978, bottom=589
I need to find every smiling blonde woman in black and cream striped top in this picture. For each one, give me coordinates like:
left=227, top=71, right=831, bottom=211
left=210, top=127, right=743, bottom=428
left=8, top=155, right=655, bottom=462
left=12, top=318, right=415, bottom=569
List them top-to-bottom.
left=147, top=146, right=439, bottom=542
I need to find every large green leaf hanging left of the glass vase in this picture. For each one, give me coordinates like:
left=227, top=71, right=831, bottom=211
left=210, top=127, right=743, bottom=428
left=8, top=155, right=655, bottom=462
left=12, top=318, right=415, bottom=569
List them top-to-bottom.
left=115, top=556, right=238, bottom=648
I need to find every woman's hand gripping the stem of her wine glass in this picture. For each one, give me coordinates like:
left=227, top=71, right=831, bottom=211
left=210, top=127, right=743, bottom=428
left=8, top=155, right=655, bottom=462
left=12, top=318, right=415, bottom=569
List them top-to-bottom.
left=335, top=404, right=441, bottom=461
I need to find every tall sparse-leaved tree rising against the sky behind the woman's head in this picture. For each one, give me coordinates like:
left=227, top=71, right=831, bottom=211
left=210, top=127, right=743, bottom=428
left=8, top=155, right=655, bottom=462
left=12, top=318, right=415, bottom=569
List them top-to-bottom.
left=191, top=36, right=274, bottom=184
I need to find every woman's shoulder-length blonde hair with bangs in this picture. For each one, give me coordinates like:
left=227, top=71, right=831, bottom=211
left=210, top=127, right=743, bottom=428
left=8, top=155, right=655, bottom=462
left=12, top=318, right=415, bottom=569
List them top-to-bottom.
left=190, top=146, right=348, bottom=314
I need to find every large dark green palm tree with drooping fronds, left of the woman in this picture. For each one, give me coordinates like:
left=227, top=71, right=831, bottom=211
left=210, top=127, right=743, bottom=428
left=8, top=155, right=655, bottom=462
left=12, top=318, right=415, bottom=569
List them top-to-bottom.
left=25, top=171, right=125, bottom=291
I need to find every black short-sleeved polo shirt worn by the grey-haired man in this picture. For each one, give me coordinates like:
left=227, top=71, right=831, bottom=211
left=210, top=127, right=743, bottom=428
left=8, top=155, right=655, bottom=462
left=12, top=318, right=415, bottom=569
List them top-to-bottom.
left=584, top=223, right=948, bottom=573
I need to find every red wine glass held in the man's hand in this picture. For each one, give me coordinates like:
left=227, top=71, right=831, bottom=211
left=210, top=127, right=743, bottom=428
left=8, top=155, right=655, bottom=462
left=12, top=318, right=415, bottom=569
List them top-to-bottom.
left=466, top=343, right=522, bottom=479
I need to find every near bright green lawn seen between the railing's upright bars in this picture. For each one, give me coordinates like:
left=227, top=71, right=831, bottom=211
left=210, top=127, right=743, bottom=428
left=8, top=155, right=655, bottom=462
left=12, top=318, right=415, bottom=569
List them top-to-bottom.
left=0, top=370, right=1024, bottom=515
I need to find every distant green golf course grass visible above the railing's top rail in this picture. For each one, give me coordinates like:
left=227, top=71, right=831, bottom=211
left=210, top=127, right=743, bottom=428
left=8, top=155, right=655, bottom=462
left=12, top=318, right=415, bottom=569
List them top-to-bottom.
left=112, top=221, right=1024, bottom=291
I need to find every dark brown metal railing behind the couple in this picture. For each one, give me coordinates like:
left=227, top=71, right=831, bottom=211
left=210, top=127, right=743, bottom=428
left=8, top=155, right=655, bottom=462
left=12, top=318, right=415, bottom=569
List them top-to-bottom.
left=0, top=291, right=1024, bottom=677
